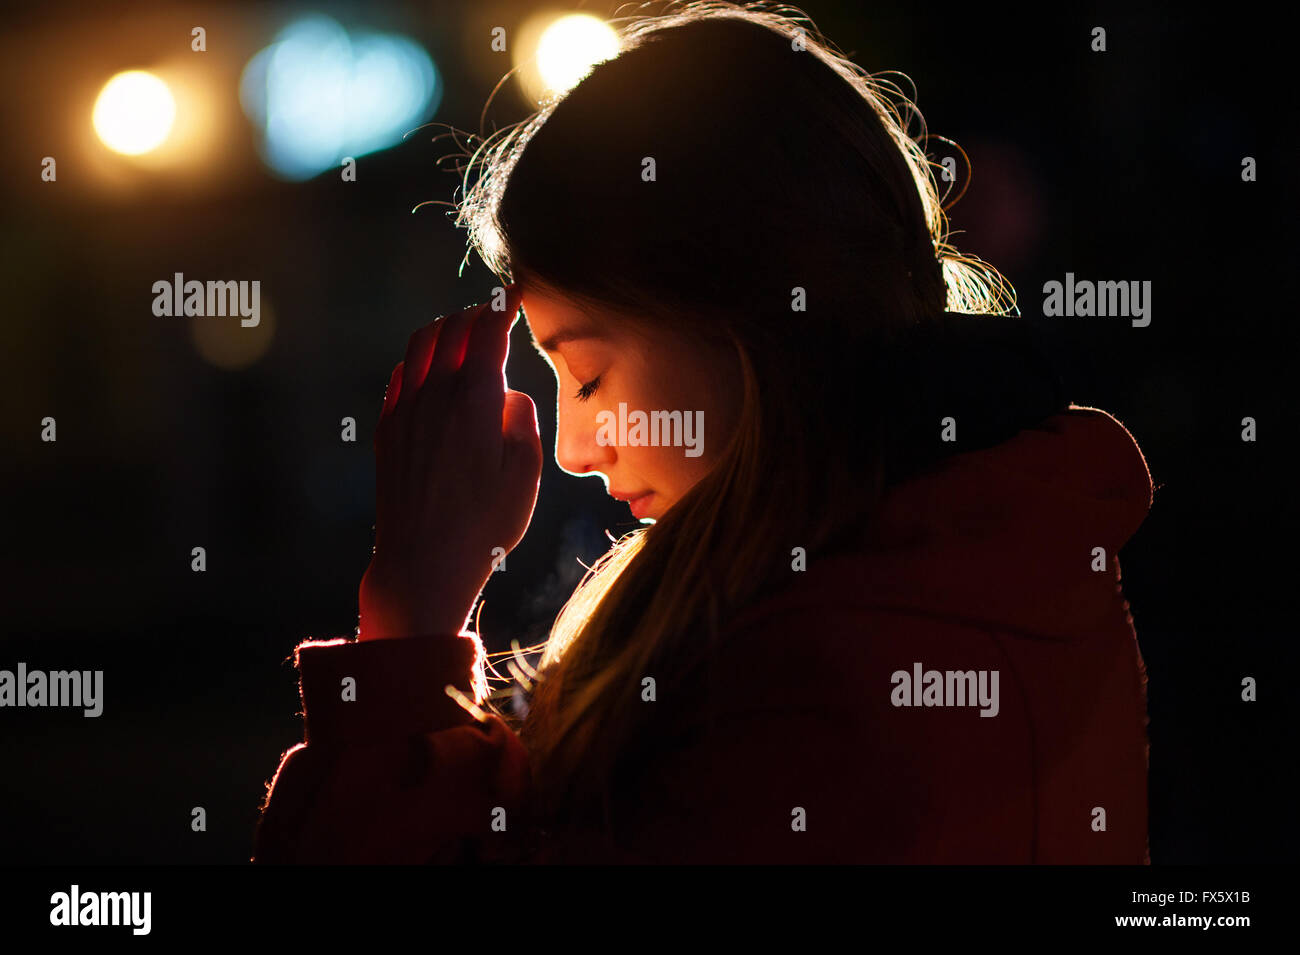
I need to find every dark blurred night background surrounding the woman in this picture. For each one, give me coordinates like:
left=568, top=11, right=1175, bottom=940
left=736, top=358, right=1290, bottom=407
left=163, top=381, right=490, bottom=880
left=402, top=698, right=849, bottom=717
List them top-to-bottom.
left=0, top=0, right=1297, bottom=864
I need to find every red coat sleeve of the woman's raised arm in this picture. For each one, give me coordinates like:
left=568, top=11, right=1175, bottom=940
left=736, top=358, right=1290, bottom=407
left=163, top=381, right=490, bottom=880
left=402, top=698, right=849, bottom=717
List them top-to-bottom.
left=252, top=633, right=529, bottom=864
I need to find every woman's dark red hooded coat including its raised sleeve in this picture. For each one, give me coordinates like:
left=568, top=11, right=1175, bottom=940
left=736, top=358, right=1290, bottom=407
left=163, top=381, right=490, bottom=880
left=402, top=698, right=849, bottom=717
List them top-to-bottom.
left=254, top=407, right=1152, bottom=864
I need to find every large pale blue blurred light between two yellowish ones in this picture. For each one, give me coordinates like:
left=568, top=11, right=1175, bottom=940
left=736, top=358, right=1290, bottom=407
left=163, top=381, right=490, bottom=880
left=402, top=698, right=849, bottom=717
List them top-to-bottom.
left=239, top=16, right=442, bottom=179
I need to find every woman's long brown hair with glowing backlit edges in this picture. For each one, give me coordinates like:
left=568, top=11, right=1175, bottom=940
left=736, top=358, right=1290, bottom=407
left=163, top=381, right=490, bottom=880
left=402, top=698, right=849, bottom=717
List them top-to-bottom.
left=458, top=3, right=1014, bottom=836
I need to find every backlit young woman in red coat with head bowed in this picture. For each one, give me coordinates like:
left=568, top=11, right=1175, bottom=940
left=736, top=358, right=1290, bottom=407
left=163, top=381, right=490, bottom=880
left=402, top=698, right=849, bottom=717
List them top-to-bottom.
left=255, top=3, right=1152, bottom=863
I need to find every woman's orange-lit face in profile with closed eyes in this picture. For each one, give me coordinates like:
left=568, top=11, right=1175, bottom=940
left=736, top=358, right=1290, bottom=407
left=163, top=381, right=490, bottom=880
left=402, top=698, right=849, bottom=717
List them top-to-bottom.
left=523, top=287, right=738, bottom=520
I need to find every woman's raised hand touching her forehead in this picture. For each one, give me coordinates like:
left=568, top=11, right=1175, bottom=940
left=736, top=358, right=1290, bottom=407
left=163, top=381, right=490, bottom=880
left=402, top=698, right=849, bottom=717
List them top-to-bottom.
left=358, top=286, right=542, bottom=639
